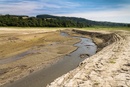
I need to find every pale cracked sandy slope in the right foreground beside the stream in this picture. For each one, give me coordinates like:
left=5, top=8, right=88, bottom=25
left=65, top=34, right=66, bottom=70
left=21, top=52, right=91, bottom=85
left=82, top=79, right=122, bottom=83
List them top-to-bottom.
left=48, top=30, right=130, bottom=87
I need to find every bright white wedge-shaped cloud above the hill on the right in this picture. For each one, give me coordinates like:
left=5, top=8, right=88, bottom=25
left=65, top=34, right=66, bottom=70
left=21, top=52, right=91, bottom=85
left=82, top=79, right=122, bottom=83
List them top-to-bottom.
left=57, top=5, right=130, bottom=23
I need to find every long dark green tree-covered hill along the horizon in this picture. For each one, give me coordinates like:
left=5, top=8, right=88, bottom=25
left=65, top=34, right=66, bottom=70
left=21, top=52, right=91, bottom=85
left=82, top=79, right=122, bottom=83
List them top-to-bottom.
left=0, top=14, right=130, bottom=27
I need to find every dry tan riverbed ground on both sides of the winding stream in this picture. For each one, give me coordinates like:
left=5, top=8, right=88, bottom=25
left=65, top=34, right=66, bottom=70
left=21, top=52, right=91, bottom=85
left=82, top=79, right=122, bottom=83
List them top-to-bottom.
left=0, top=29, right=130, bottom=87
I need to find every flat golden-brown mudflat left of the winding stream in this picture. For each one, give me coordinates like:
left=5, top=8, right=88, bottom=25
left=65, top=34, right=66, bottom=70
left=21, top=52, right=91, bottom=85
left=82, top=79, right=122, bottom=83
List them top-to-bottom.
left=0, top=28, right=80, bottom=85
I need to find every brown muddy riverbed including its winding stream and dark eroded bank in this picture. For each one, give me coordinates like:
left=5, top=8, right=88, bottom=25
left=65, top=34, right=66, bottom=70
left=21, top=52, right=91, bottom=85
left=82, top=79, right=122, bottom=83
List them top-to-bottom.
left=0, top=29, right=115, bottom=87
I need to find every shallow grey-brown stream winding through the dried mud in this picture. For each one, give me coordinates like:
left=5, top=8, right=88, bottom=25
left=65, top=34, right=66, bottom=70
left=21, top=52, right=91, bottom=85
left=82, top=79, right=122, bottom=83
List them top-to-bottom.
left=2, top=32, right=97, bottom=87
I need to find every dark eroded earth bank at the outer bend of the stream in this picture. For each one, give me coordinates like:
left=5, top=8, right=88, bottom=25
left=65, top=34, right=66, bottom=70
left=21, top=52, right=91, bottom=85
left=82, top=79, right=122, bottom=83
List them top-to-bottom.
left=72, top=30, right=116, bottom=52
